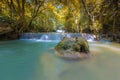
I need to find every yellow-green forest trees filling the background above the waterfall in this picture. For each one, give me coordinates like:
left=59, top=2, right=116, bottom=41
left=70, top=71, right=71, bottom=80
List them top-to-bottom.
left=0, top=0, right=120, bottom=34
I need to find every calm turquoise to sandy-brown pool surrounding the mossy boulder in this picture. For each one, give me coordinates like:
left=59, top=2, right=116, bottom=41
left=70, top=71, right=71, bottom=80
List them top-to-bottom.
left=0, top=40, right=120, bottom=80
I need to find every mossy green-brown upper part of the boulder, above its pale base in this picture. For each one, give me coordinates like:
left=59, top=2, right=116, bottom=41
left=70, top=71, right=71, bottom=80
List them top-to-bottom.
left=55, top=37, right=89, bottom=54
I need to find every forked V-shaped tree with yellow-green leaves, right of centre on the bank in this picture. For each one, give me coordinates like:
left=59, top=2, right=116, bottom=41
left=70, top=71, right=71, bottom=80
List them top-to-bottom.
left=81, top=0, right=104, bottom=35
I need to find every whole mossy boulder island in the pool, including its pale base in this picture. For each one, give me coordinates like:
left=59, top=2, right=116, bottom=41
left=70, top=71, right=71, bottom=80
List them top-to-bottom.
left=55, top=37, right=90, bottom=59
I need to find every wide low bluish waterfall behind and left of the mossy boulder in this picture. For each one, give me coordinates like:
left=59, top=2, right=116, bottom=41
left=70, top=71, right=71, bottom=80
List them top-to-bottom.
left=20, top=33, right=87, bottom=42
